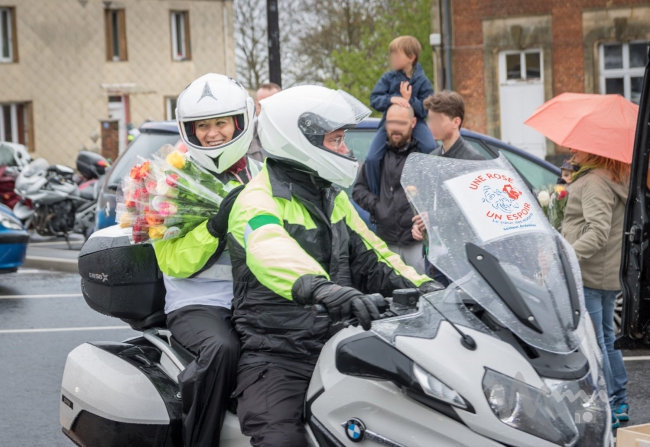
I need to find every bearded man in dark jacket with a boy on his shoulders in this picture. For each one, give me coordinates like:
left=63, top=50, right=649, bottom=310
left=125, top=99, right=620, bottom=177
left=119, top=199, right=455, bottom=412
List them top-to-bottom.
left=352, top=105, right=424, bottom=273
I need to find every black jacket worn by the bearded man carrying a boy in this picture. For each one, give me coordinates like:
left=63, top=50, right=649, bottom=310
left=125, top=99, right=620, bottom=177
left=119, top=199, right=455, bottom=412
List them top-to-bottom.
left=352, top=139, right=420, bottom=245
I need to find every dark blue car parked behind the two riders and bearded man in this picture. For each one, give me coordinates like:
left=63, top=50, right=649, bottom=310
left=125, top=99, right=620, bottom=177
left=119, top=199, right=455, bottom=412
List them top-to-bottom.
left=95, top=118, right=560, bottom=229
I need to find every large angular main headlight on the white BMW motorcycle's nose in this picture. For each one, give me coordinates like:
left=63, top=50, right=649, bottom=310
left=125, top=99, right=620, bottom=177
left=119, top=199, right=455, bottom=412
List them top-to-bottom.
left=483, top=369, right=579, bottom=445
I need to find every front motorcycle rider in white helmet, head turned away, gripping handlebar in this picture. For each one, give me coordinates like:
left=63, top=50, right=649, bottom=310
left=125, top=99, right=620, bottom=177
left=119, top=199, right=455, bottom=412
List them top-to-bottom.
left=228, top=86, right=439, bottom=447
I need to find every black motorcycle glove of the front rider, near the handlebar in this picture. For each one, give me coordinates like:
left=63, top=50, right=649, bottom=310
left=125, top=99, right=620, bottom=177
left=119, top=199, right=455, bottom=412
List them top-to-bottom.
left=312, top=281, right=379, bottom=331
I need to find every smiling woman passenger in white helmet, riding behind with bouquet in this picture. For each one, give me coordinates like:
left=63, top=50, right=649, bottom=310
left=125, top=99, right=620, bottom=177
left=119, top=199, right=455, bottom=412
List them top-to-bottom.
left=154, top=73, right=261, bottom=447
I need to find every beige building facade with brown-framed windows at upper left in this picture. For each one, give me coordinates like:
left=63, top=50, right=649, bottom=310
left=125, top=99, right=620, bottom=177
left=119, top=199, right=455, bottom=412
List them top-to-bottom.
left=0, top=0, right=235, bottom=165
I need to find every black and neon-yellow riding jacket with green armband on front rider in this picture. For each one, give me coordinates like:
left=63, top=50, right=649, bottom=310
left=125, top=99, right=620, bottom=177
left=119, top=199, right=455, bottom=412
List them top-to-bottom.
left=228, top=159, right=427, bottom=365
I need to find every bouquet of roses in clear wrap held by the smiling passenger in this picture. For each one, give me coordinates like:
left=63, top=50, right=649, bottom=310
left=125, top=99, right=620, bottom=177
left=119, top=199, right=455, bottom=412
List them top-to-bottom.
left=116, top=145, right=233, bottom=244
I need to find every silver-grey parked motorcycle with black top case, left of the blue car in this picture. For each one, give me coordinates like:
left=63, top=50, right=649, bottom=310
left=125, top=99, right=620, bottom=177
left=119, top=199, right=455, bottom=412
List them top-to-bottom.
left=14, top=151, right=109, bottom=240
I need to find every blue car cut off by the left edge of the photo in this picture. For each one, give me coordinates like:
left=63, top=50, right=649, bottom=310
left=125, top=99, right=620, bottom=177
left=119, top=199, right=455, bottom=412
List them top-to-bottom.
left=0, top=204, right=29, bottom=273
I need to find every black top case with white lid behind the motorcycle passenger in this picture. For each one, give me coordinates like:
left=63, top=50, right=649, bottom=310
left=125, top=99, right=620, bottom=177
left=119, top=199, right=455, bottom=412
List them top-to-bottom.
left=78, top=225, right=165, bottom=329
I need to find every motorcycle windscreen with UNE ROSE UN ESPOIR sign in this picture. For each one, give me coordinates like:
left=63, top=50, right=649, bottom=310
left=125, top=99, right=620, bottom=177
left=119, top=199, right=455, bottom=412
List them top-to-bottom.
left=401, top=154, right=584, bottom=353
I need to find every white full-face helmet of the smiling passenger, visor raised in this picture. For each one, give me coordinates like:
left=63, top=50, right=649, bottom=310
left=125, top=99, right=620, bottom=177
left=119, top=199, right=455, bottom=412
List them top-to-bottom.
left=176, top=73, right=255, bottom=174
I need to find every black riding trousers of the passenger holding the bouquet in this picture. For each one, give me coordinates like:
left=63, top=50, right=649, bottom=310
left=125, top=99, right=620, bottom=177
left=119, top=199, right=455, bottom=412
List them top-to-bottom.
left=167, top=305, right=239, bottom=447
